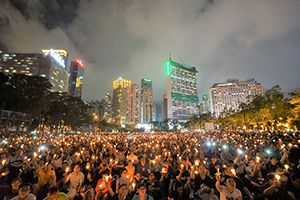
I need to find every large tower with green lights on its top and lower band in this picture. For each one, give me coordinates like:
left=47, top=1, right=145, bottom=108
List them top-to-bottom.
left=166, top=58, right=199, bottom=121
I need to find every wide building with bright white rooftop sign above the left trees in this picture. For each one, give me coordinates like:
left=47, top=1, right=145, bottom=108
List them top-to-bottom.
left=0, top=52, right=69, bottom=93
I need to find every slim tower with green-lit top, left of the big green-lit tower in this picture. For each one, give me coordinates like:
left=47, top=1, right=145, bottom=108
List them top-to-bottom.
left=141, top=78, right=155, bottom=123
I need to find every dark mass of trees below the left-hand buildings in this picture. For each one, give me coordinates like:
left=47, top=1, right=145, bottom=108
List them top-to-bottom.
left=0, top=73, right=92, bottom=131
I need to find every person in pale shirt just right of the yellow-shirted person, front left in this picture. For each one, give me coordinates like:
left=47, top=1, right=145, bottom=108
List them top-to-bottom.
left=65, top=164, right=84, bottom=200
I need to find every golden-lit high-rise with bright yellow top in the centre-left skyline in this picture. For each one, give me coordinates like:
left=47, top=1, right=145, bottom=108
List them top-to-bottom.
left=112, top=77, right=131, bottom=126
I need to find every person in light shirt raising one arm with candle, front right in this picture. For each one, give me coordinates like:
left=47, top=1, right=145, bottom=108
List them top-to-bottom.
left=216, top=173, right=242, bottom=200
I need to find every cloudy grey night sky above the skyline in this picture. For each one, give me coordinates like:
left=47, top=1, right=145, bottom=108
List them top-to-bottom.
left=0, top=0, right=300, bottom=101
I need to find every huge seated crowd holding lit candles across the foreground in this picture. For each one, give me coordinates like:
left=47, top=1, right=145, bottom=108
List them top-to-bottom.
left=0, top=131, right=300, bottom=200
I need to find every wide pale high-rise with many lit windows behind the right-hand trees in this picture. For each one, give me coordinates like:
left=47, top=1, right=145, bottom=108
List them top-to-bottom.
left=209, top=79, right=262, bottom=117
